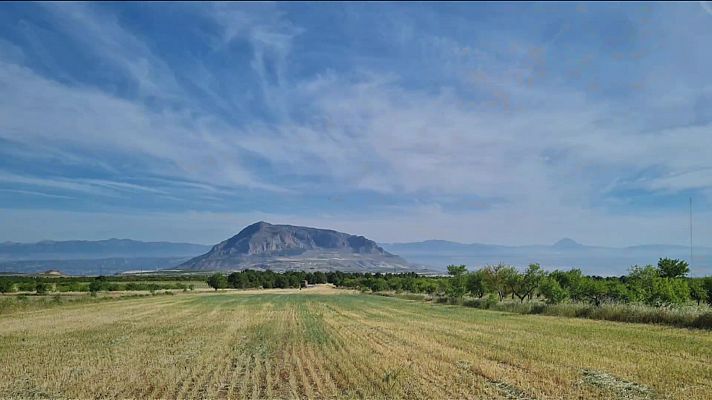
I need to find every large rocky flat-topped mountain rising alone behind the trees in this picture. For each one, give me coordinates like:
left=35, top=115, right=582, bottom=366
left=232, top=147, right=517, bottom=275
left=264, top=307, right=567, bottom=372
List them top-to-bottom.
left=180, top=222, right=411, bottom=271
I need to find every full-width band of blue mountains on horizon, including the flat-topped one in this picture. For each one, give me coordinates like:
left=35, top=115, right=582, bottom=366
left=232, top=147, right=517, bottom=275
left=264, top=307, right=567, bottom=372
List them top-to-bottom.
left=0, top=233, right=712, bottom=275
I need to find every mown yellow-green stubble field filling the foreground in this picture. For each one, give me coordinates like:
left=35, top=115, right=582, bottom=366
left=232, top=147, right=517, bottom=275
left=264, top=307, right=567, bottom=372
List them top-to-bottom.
left=0, top=288, right=712, bottom=399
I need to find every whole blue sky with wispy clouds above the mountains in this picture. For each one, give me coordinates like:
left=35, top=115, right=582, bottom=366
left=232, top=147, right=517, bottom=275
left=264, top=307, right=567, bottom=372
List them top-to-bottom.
left=0, top=2, right=712, bottom=246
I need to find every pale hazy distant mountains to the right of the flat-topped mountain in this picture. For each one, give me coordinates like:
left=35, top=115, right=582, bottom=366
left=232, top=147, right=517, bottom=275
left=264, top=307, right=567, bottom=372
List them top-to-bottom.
left=381, top=238, right=712, bottom=275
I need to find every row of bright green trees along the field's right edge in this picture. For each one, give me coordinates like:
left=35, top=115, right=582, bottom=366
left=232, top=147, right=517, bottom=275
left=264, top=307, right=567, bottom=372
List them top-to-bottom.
left=348, top=258, right=712, bottom=306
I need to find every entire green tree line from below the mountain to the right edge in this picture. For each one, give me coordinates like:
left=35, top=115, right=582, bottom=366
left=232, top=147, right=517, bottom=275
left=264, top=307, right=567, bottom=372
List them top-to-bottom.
left=202, top=258, right=712, bottom=306
